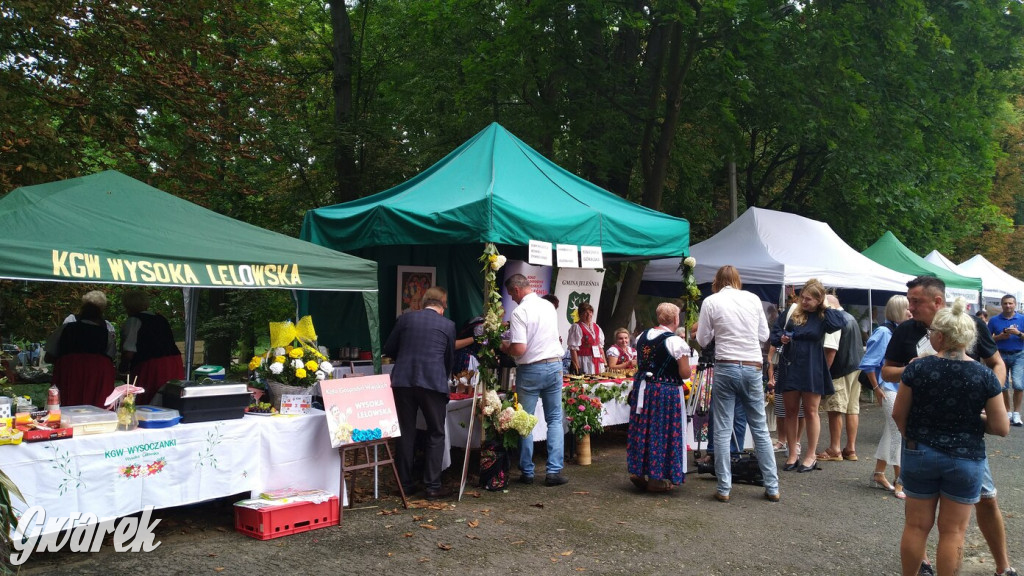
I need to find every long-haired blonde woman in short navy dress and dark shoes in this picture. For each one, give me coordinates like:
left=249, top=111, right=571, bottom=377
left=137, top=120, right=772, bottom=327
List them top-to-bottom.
left=771, top=279, right=846, bottom=472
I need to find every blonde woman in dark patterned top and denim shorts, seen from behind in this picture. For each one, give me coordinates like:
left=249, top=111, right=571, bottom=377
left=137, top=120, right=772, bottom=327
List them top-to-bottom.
left=893, top=298, right=1010, bottom=576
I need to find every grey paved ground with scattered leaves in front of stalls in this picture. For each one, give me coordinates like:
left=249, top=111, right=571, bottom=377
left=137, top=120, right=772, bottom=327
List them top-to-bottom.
left=22, top=403, right=1024, bottom=576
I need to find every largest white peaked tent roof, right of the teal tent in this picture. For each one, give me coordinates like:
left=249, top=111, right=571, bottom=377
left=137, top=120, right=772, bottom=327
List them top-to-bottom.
left=643, top=208, right=911, bottom=301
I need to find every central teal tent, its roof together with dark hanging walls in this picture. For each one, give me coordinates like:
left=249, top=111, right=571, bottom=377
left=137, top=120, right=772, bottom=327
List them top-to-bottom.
left=300, top=124, right=689, bottom=345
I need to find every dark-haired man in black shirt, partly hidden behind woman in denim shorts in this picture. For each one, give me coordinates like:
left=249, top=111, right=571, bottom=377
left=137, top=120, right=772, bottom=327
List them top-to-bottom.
left=882, top=276, right=1017, bottom=575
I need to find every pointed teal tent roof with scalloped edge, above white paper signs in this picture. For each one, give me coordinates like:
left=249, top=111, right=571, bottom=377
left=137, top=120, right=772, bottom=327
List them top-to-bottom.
left=301, top=124, right=689, bottom=258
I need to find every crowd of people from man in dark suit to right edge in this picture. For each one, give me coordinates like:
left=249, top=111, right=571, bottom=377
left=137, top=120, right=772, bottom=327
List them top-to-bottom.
left=385, top=265, right=1024, bottom=576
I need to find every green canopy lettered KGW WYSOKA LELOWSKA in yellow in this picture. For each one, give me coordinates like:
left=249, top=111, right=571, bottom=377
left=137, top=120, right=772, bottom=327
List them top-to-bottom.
left=0, top=170, right=380, bottom=361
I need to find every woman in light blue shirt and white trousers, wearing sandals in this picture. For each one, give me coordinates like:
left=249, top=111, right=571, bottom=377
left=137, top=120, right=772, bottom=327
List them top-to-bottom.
left=859, top=294, right=910, bottom=494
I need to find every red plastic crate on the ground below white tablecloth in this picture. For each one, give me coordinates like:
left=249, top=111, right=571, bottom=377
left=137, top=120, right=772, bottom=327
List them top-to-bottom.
left=234, top=496, right=338, bottom=540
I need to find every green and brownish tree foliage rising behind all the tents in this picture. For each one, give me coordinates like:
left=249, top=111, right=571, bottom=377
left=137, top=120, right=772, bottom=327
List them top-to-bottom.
left=0, top=0, right=1024, bottom=342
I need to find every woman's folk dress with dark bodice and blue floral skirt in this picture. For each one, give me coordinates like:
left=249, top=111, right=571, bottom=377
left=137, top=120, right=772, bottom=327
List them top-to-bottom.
left=626, top=332, right=686, bottom=484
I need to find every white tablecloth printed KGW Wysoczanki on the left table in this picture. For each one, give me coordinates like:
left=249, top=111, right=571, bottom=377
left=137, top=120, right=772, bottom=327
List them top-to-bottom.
left=0, top=411, right=341, bottom=535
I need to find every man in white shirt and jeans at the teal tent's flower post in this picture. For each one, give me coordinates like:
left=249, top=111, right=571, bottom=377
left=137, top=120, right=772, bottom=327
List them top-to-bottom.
left=502, top=274, right=568, bottom=486
